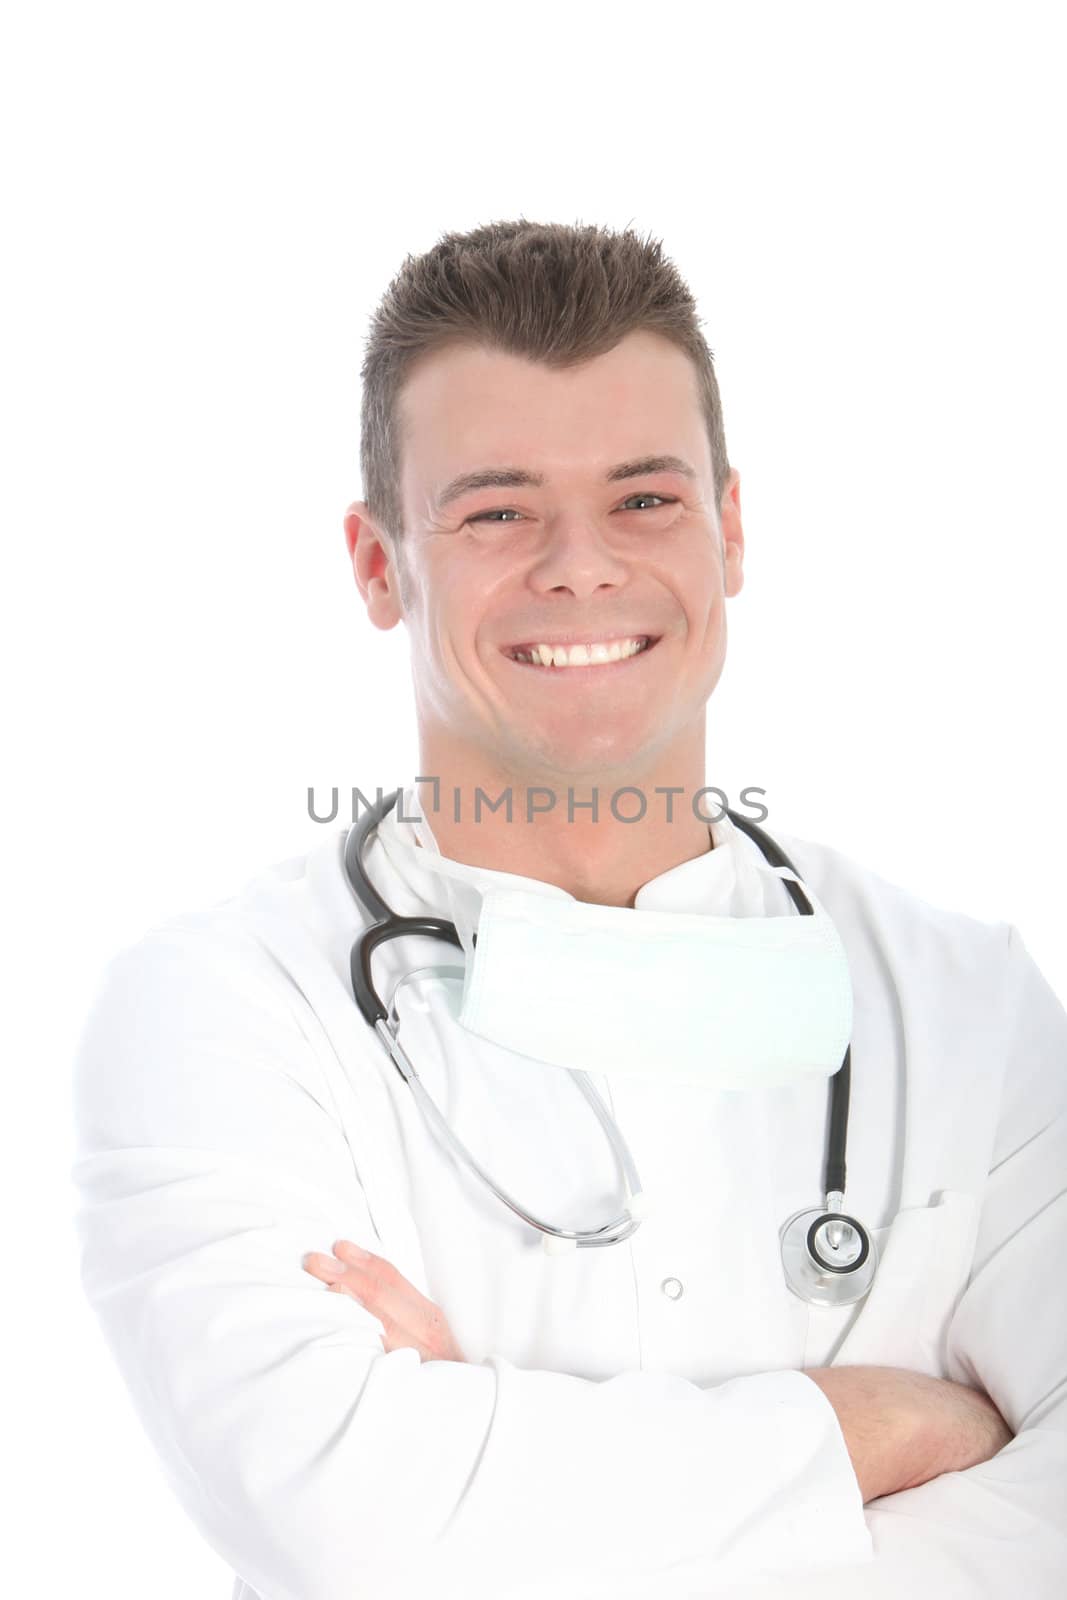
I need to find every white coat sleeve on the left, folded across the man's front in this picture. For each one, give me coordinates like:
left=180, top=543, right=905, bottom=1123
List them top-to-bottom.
left=72, top=925, right=870, bottom=1600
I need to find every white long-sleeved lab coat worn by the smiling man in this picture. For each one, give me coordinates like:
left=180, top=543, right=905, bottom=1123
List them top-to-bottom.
left=74, top=789, right=1067, bottom=1600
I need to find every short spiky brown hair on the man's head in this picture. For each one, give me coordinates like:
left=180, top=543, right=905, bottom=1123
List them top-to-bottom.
left=360, top=219, right=731, bottom=539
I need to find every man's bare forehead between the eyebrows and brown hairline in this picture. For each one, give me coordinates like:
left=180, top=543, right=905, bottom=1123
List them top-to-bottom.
left=400, top=331, right=712, bottom=514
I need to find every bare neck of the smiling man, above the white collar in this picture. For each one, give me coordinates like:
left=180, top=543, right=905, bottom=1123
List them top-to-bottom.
left=416, top=741, right=721, bottom=906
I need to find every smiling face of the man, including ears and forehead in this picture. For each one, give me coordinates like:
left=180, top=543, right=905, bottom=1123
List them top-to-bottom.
left=346, top=331, right=744, bottom=779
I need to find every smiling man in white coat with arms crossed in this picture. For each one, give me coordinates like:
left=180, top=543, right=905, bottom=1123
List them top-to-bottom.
left=75, top=222, right=1067, bottom=1600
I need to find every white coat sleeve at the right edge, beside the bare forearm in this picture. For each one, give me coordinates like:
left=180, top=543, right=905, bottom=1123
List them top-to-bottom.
left=703, top=925, right=1067, bottom=1600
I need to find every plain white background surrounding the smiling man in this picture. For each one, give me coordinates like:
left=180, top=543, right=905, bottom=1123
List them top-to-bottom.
left=0, top=0, right=1067, bottom=1600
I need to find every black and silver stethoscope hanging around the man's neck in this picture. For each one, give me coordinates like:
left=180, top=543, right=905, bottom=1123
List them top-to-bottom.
left=344, top=789, right=878, bottom=1306
